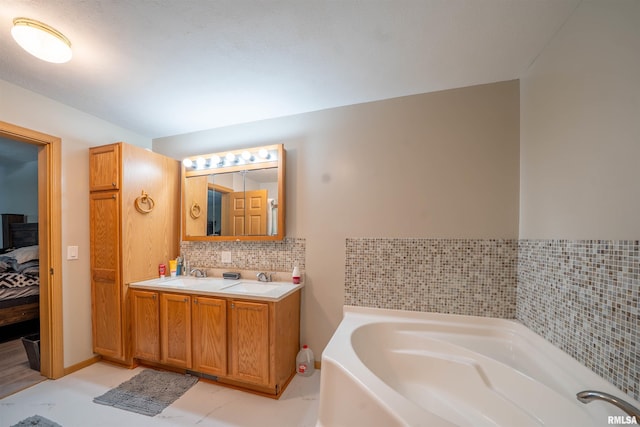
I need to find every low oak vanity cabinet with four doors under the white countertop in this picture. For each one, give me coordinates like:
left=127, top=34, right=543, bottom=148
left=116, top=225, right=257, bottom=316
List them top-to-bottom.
left=131, top=289, right=300, bottom=396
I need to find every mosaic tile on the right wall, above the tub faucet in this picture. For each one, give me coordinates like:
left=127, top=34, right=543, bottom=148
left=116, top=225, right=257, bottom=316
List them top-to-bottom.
left=516, top=240, right=640, bottom=400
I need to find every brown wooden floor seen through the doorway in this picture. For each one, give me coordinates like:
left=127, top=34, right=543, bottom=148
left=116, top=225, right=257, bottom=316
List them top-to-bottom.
left=0, top=339, right=46, bottom=399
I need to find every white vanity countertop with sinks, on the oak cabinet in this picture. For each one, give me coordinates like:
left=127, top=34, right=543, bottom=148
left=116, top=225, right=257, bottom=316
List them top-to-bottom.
left=129, top=276, right=304, bottom=301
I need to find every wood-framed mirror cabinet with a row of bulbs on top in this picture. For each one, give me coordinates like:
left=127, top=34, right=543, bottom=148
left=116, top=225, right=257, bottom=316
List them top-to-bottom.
left=182, top=144, right=285, bottom=241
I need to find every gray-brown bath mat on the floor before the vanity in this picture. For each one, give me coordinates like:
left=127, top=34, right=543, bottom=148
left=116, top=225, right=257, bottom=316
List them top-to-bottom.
left=93, top=369, right=198, bottom=417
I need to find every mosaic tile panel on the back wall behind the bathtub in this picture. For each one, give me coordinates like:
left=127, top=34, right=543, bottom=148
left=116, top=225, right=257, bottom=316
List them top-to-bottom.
left=344, top=238, right=517, bottom=319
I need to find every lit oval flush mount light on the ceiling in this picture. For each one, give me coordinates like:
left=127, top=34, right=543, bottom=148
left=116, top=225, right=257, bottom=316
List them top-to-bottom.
left=11, top=18, right=72, bottom=64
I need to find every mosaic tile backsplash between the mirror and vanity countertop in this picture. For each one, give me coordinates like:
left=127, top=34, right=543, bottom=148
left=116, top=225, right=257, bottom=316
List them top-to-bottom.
left=180, top=238, right=306, bottom=272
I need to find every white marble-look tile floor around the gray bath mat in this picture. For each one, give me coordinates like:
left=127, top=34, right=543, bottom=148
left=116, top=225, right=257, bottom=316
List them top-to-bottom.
left=0, top=363, right=320, bottom=427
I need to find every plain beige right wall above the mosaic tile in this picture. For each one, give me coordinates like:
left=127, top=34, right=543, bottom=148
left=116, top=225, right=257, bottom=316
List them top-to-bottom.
left=520, top=0, right=640, bottom=239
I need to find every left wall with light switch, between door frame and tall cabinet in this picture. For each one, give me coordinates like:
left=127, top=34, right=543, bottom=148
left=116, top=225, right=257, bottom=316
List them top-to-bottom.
left=0, top=80, right=151, bottom=367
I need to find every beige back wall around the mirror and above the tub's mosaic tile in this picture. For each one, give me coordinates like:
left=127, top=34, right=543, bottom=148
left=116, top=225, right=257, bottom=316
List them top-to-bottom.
left=153, top=81, right=519, bottom=359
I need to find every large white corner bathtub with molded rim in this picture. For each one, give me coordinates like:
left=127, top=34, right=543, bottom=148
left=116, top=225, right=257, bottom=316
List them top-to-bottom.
left=317, top=306, right=640, bottom=427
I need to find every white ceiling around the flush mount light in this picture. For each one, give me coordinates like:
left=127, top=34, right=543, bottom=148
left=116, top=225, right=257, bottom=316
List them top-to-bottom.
left=0, top=0, right=582, bottom=138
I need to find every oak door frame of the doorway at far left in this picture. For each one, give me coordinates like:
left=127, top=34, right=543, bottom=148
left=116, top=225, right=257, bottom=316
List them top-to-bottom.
left=0, top=121, right=64, bottom=379
